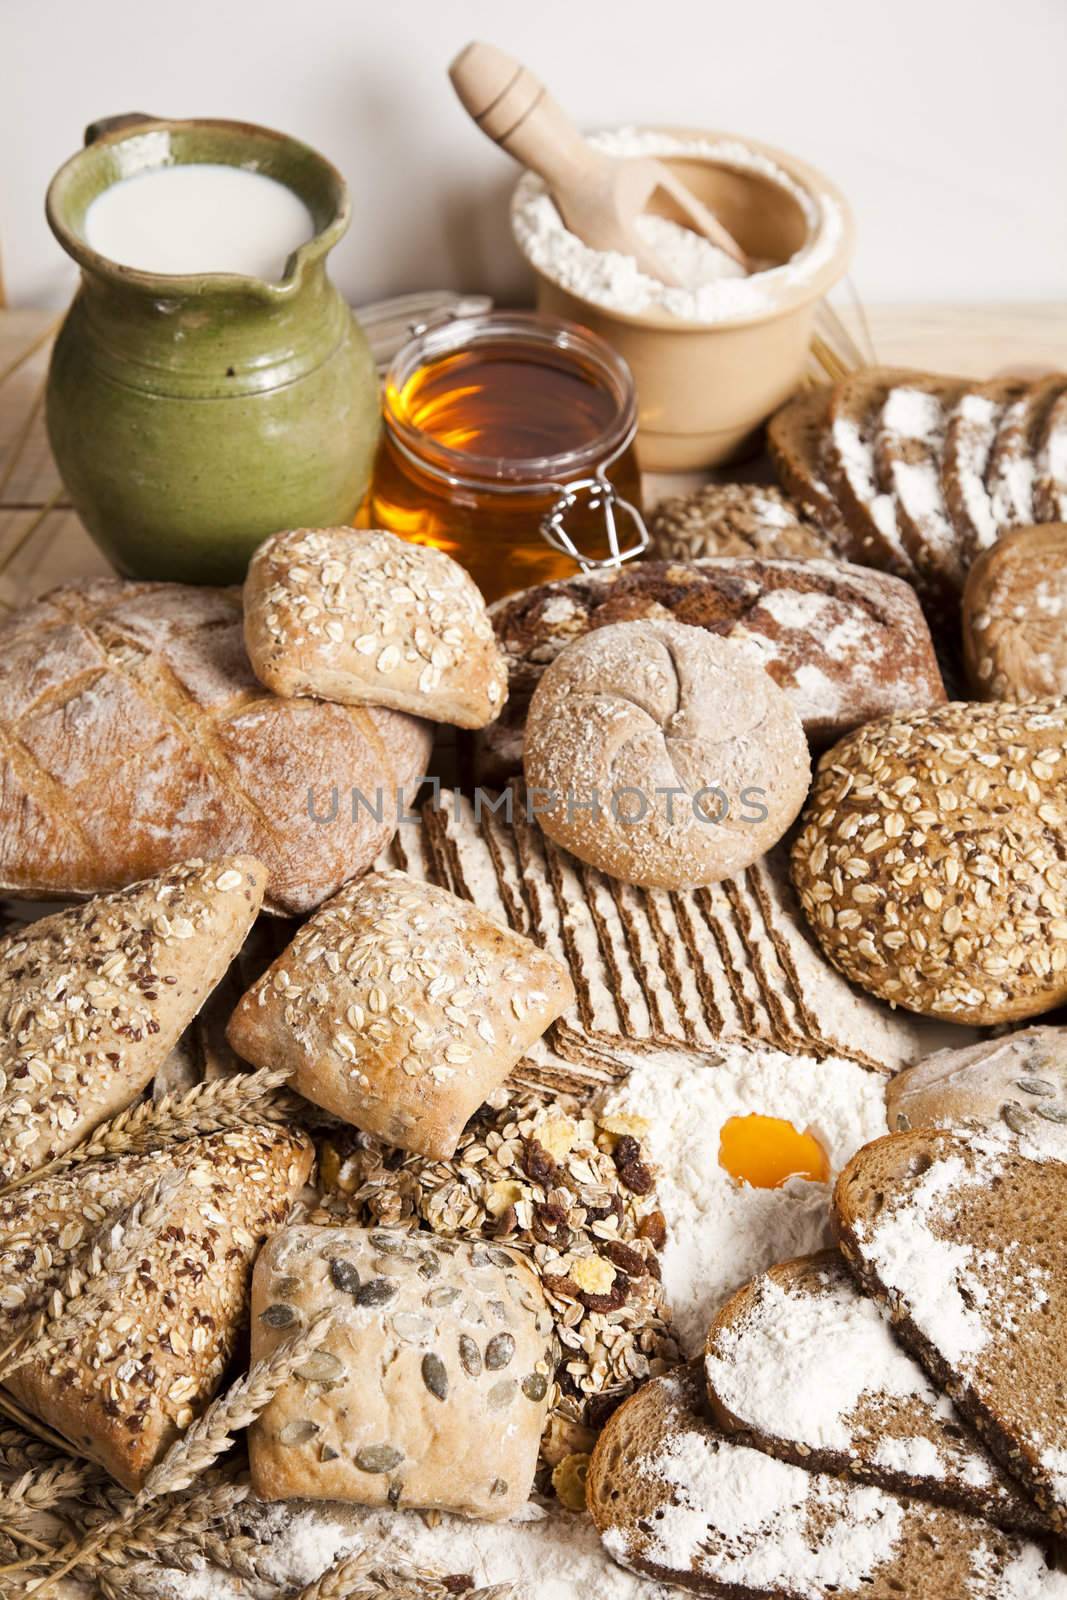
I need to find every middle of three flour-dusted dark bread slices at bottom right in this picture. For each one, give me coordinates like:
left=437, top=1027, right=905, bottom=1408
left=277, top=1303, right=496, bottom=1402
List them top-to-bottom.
left=704, top=1250, right=1049, bottom=1534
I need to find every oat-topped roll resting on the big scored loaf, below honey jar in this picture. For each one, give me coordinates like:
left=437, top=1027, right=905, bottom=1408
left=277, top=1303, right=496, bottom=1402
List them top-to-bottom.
left=245, top=528, right=507, bottom=728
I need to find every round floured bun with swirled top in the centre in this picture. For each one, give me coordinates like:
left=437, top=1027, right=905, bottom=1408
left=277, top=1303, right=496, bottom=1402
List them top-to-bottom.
left=523, top=621, right=811, bottom=890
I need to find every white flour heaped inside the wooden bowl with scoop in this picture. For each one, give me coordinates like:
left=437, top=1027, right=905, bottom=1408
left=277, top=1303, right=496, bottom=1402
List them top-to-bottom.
left=512, top=128, right=843, bottom=323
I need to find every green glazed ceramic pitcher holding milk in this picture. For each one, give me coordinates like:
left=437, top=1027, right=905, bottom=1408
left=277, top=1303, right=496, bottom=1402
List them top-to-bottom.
left=46, top=115, right=379, bottom=584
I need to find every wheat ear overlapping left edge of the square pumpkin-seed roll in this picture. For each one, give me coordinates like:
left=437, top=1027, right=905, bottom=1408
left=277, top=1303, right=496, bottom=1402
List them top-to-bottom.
left=27, top=1310, right=333, bottom=1595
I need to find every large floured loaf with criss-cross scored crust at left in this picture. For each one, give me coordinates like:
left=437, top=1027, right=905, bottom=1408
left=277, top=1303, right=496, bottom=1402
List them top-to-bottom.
left=0, top=579, right=430, bottom=914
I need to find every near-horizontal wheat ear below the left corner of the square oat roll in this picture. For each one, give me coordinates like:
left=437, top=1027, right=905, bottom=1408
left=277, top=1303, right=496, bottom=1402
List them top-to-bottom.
left=0, top=1067, right=300, bottom=1200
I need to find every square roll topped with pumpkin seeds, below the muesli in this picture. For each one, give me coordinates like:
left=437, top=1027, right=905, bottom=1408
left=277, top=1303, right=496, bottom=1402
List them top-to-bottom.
left=248, top=1227, right=557, bottom=1522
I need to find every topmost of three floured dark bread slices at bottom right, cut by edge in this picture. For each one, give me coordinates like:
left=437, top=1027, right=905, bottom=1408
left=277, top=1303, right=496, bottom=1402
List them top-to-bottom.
left=833, top=1130, right=1067, bottom=1531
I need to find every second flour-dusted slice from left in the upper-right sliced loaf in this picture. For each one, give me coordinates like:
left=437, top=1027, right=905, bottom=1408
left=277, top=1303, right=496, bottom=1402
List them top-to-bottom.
left=875, top=376, right=966, bottom=614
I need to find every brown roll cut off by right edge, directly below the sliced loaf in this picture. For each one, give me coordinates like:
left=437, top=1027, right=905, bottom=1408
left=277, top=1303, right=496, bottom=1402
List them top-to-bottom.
left=963, top=522, right=1067, bottom=701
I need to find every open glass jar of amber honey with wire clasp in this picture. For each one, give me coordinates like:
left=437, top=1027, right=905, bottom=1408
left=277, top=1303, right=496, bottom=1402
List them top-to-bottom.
left=358, top=312, right=648, bottom=600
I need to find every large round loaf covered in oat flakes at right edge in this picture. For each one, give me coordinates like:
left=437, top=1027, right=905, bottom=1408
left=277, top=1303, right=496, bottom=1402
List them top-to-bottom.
left=792, top=701, right=1067, bottom=1024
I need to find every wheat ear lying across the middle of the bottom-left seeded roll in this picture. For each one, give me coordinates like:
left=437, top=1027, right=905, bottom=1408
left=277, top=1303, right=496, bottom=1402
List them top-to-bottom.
left=0, top=1168, right=186, bottom=1382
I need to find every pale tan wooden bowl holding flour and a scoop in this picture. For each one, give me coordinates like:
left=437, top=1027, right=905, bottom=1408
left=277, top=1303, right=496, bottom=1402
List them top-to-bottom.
left=512, top=128, right=853, bottom=472
